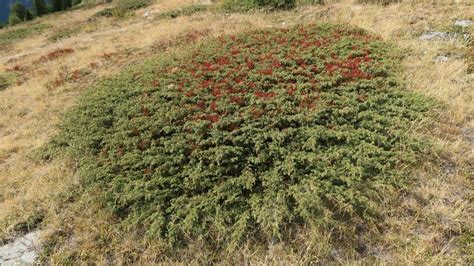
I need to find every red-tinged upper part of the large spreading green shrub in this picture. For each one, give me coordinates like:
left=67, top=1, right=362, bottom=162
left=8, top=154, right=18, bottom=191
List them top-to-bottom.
left=152, top=27, right=382, bottom=128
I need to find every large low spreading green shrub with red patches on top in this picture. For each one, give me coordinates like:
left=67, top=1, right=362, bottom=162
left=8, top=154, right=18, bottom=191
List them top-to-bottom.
left=54, top=25, right=430, bottom=254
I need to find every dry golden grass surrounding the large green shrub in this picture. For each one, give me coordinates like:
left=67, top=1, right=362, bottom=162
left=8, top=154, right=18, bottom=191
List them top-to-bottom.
left=0, top=0, right=474, bottom=264
